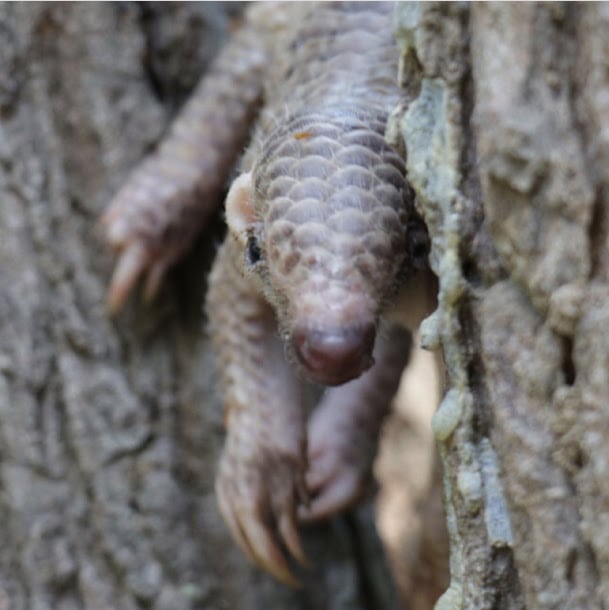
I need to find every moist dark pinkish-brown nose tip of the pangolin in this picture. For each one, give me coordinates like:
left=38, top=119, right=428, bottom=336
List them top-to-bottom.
left=292, top=322, right=376, bottom=385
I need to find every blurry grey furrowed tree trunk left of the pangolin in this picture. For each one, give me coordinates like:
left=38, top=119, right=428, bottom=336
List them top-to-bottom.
left=0, top=3, right=395, bottom=610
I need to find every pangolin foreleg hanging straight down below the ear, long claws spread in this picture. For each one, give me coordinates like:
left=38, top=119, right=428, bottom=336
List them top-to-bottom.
left=207, top=235, right=307, bottom=585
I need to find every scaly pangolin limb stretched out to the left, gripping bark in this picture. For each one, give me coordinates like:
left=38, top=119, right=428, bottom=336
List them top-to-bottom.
left=102, top=21, right=267, bottom=313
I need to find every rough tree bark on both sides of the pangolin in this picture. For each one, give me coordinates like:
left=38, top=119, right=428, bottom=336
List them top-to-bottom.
left=0, top=3, right=609, bottom=610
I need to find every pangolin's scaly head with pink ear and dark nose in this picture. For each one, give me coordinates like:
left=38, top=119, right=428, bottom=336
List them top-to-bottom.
left=227, top=117, right=426, bottom=385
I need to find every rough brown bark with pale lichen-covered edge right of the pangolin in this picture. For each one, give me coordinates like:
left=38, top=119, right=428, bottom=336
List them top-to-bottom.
left=398, top=3, right=609, bottom=610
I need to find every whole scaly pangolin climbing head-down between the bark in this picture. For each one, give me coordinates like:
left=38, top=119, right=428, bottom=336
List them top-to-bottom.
left=104, top=2, right=426, bottom=582
